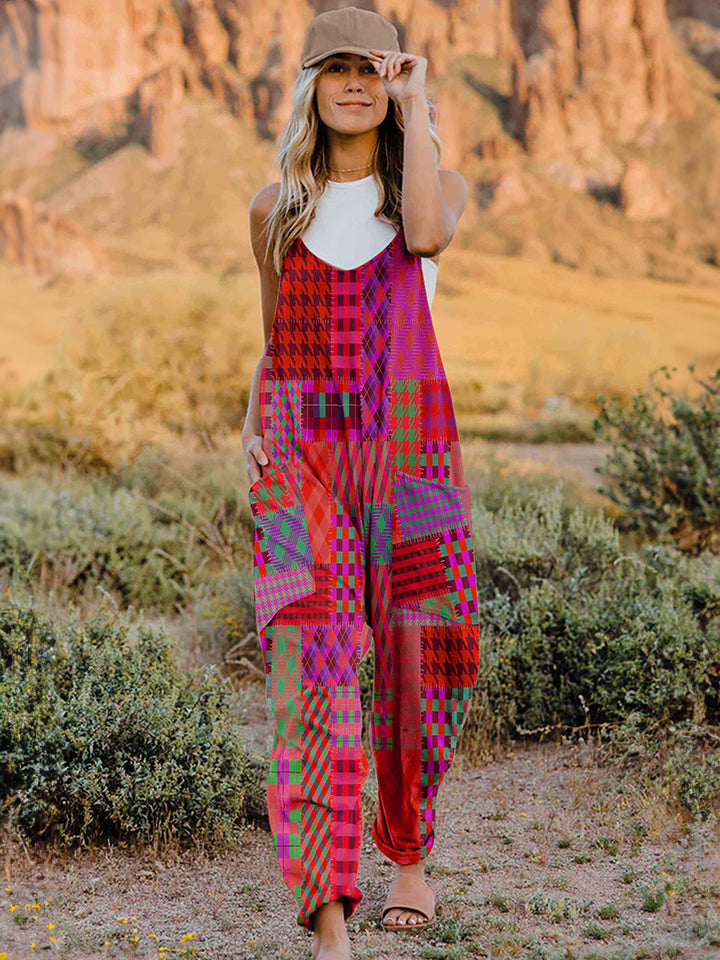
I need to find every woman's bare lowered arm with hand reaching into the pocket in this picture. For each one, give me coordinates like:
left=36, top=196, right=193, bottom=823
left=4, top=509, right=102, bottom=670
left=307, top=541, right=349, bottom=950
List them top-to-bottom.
left=242, top=183, right=280, bottom=484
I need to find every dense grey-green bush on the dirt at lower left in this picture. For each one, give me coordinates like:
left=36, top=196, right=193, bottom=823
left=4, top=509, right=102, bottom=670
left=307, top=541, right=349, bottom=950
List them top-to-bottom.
left=0, top=602, right=265, bottom=849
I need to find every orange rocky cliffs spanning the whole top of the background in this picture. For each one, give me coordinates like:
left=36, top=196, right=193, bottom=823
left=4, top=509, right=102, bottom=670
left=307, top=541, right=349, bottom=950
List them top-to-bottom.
left=0, top=0, right=720, bottom=282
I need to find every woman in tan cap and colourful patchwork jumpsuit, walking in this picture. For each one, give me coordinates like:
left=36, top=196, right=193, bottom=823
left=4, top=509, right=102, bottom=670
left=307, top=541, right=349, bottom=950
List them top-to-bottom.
left=243, top=7, right=479, bottom=960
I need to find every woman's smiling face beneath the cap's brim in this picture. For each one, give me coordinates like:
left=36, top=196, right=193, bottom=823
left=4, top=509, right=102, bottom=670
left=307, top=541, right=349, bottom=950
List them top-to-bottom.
left=315, top=53, right=388, bottom=133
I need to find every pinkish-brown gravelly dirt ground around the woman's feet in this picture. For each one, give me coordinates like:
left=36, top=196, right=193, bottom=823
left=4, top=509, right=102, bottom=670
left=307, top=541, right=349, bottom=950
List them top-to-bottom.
left=0, top=684, right=720, bottom=960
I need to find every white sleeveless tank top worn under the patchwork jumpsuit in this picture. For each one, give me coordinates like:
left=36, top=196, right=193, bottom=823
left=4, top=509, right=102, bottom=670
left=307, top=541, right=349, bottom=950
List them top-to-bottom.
left=302, top=173, right=438, bottom=305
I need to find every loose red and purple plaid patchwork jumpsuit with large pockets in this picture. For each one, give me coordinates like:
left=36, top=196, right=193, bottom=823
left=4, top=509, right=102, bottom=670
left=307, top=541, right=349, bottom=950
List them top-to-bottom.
left=249, top=227, right=479, bottom=929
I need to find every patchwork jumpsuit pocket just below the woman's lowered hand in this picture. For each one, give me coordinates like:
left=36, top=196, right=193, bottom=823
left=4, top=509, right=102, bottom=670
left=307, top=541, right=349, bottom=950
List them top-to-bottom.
left=248, top=467, right=315, bottom=634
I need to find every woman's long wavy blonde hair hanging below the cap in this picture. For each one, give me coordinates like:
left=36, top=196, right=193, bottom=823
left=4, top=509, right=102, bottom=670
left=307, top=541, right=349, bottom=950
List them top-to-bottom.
left=264, top=60, right=442, bottom=275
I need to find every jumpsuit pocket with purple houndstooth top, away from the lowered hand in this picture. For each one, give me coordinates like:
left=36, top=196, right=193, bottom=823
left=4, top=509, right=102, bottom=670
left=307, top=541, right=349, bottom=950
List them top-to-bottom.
left=392, top=470, right=477, bottom=623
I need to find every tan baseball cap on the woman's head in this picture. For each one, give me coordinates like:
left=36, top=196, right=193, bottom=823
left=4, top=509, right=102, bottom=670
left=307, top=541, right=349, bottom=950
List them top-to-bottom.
left=300, top=6, right=400, bottom=70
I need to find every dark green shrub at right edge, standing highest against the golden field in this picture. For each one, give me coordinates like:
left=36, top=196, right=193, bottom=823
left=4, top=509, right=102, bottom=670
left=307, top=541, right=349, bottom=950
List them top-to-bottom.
left=593, top=364, right=720, bottom=553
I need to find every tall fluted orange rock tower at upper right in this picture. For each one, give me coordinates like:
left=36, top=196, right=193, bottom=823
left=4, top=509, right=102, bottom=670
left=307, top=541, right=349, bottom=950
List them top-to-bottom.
left=512, top=0, right=692, bottom=159
